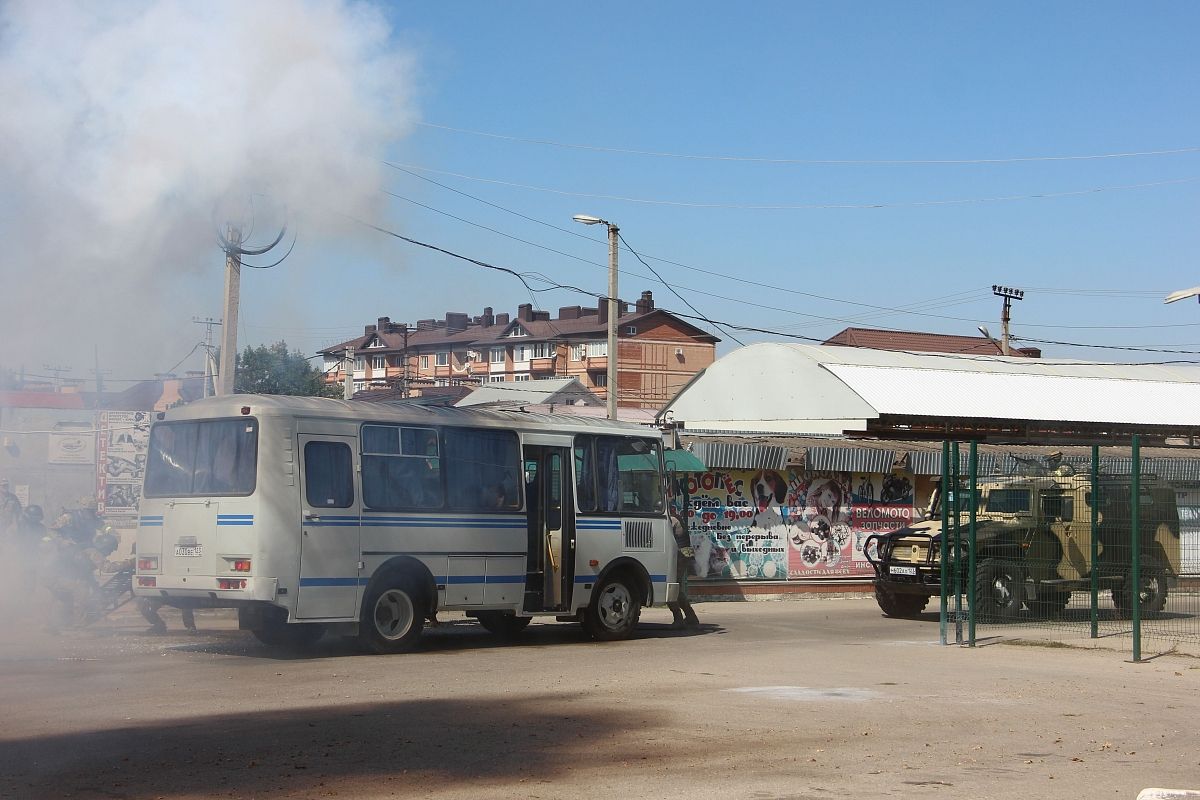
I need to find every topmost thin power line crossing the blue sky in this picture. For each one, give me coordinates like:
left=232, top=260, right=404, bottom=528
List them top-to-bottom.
left=416, top=122, right=1200, bottom=166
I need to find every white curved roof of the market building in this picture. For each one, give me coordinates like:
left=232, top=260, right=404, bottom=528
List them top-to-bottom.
left=666, top=343, right=1200, bottom=434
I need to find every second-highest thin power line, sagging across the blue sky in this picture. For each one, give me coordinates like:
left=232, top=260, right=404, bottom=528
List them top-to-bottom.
left=384, top=161, right=1200, bottom=211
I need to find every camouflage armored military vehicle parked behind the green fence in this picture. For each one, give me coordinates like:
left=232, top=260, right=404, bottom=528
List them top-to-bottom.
left=864, top=468, right=1180, bottom=620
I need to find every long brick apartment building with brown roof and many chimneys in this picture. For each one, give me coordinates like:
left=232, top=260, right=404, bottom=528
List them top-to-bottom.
left=320, top=291, right=720, bottom=409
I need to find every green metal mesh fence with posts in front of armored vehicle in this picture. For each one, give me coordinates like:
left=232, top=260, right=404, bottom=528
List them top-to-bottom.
left=938, top=438, right=1200, bottom=661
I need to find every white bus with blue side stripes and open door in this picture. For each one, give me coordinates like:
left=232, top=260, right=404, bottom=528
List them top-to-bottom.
left=134, top=395, right=678, bottom=652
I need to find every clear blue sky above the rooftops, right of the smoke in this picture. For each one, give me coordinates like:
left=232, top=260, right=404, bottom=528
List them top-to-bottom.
left=0, top=0, right=1200, bottom=381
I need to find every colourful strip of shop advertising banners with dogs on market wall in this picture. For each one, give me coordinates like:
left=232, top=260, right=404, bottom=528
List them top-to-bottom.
left=688, top=470, right=912, bottom=581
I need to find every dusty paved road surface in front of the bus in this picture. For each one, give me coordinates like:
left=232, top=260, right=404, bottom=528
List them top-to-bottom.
left=0, top=599, right=1200, bottom=800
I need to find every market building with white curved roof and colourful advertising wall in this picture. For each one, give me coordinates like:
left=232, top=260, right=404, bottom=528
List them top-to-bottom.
left=659, top=343, right=1200, bottom=583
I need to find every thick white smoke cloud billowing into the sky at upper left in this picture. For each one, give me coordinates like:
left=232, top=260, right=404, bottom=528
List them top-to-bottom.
left=0, top=0, right=414, bottom=377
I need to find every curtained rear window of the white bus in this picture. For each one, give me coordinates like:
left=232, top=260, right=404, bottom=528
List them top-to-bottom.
left=144, top=417, right=258, bottom=498
